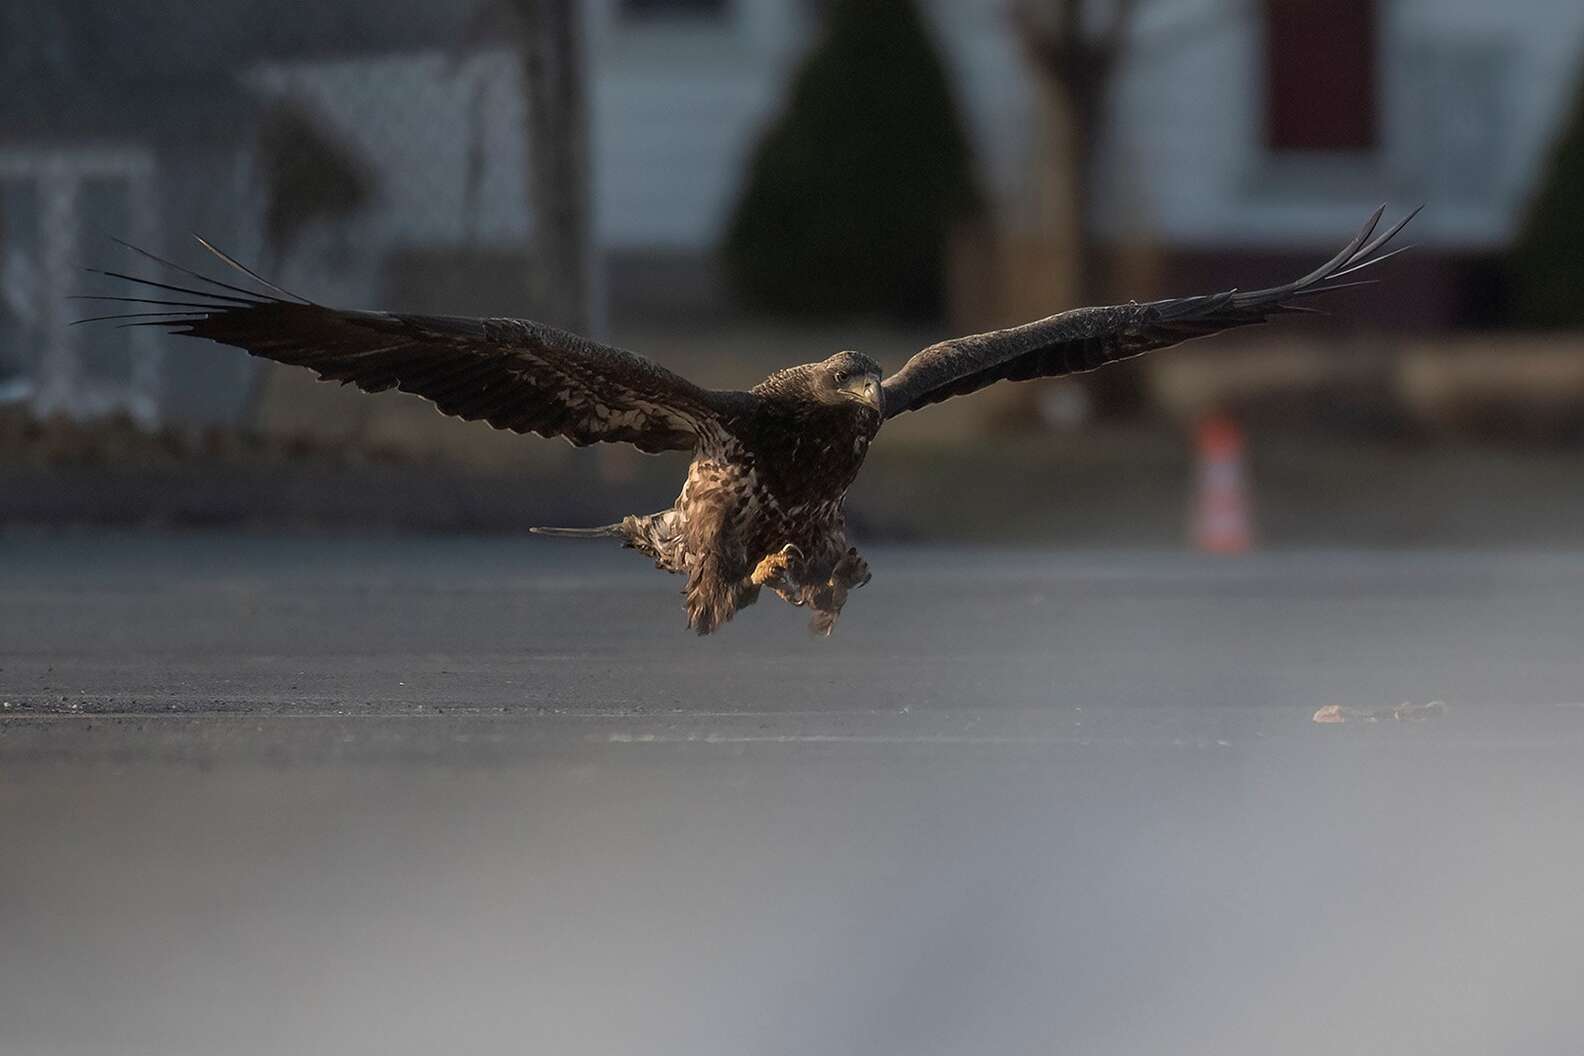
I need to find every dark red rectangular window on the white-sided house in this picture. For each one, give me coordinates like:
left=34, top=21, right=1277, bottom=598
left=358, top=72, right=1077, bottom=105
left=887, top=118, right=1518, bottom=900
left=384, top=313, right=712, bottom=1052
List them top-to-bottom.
left=1264, top=0, right=1378, bottom=150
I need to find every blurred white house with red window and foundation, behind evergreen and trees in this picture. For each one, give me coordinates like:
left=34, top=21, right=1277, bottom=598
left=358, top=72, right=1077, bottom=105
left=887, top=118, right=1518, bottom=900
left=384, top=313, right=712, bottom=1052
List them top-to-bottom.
left=591, top=0, right=1584, bottom=329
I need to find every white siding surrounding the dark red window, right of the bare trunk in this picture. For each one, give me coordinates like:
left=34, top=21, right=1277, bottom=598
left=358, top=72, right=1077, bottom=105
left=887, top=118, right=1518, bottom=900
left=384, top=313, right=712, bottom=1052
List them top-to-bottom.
left=1102, top=0, right=1584, bottom=249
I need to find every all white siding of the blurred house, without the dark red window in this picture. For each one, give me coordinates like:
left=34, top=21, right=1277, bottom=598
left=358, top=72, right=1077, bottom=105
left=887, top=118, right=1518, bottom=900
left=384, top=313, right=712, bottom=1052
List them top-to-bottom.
left=591, top=0, right=1584, bottom=250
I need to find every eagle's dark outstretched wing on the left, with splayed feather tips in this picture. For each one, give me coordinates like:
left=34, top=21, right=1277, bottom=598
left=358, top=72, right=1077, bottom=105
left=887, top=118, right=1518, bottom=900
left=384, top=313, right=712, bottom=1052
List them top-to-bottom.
left=79, top=239, right=754, bottom=453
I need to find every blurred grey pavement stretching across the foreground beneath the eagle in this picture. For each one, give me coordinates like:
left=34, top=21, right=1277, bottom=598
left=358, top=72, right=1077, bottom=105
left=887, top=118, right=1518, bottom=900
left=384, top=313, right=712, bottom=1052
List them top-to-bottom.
left=0, top=535, right=1584, bottom=1056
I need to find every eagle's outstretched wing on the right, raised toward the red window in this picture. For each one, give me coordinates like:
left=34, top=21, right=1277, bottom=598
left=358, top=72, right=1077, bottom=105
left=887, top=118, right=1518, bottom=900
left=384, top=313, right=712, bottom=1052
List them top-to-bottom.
left=884, top=206, right=1422, bottom=418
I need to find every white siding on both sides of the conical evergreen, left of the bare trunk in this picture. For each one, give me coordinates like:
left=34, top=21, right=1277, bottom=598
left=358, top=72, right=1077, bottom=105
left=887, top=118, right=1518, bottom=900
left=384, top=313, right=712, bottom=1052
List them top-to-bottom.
left=591, top=0, right=1034, bottom=252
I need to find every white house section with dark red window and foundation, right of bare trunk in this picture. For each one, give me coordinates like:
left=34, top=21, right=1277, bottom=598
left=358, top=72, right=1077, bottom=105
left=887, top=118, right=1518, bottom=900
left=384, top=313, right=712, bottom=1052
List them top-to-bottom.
left=1099, top=0, right=1584, bottom=329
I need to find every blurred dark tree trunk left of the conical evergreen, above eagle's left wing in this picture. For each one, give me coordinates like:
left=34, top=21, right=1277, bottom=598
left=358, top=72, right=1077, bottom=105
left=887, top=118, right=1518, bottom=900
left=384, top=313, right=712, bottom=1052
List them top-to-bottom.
left=510, top=0, right=594, bottom=332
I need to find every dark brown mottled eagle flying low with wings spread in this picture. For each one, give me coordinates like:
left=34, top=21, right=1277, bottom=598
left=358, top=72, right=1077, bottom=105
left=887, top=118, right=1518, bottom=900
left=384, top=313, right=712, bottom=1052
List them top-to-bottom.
left=81, top=206, right=1418, bottom=635
